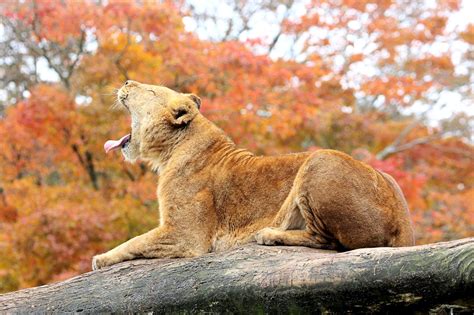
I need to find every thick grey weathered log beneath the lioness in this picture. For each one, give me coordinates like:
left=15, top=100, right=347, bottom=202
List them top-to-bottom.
left=0, top=238, right=474, bottom=314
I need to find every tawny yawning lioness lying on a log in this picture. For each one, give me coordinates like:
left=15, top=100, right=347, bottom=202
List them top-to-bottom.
left=92, top=81, right=414, bottom=269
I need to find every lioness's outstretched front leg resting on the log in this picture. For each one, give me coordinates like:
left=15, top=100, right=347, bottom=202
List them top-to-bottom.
left=92, top=227, right=200, bottom=270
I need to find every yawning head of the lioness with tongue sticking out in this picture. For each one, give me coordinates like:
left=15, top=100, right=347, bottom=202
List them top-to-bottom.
left=104, top=80, right=201, bottom=162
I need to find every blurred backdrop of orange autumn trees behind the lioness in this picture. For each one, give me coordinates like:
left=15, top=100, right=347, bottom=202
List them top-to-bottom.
left=0, top=0, right=474, bottom=292
